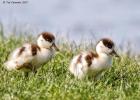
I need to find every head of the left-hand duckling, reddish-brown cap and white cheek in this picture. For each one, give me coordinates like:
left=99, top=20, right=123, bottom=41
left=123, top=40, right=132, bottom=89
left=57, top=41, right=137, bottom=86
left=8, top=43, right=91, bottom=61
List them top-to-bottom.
left=37, top=32, right=59, bottom=51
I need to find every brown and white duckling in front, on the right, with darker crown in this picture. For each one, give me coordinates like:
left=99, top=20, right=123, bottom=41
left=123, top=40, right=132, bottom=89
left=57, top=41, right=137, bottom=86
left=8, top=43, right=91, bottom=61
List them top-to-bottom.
left=69, top=38, right=119, bottom=79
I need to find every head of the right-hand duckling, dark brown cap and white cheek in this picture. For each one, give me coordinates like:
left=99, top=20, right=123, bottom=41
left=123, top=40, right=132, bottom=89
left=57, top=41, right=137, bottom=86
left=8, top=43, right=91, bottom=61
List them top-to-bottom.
left=96, top=38, right=119, bottom=57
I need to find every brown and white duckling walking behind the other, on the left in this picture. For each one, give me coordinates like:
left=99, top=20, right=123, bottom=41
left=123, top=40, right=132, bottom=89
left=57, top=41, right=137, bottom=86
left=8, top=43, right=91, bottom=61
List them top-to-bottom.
left=4, top=32, right=59, bottom=72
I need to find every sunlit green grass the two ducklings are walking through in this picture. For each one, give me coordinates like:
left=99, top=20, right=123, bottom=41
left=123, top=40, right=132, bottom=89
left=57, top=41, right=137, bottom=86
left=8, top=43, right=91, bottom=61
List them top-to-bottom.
left=0, top=37, right=140, bottom=100
